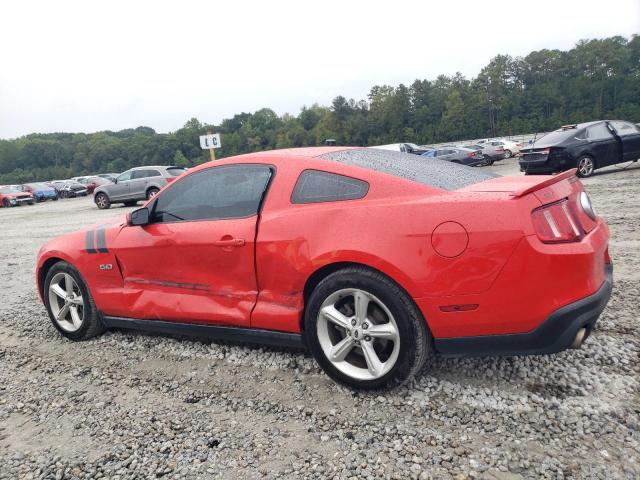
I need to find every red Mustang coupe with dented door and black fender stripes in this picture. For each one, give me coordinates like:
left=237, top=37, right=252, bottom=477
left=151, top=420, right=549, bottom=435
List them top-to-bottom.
left=37, top=147, right=612, bottom=389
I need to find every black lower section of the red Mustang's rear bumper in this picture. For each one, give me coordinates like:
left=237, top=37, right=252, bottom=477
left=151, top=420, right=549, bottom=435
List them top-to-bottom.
left=434, top=264, right=613, bottom=357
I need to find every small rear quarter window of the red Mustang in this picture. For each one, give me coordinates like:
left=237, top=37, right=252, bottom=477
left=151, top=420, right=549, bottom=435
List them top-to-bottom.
left=291, top=170, right=369, bottom=204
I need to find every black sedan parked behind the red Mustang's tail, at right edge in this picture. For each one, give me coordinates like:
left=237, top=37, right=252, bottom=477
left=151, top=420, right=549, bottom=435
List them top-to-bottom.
left=520, top=120, right=640, bottom=177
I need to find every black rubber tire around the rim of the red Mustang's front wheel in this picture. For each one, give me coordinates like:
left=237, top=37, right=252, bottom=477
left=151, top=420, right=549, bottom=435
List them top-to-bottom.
left=42, top=261, right=105, bottom=341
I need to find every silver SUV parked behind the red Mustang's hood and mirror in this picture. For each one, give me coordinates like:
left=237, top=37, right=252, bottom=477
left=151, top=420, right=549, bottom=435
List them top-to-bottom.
left=93, top=166, right=186, bottom=209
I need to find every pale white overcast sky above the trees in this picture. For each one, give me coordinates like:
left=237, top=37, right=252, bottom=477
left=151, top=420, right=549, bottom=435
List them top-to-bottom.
left=0, top=0, right=640, bottom=138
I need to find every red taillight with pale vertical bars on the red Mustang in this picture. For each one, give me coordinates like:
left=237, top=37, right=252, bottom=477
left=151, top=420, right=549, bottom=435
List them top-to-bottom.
left=531, top=198, right=583, bottom=243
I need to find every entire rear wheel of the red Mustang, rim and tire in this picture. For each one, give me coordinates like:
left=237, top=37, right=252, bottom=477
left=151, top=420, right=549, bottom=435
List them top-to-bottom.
left=305, top=267, right=431, bottom=390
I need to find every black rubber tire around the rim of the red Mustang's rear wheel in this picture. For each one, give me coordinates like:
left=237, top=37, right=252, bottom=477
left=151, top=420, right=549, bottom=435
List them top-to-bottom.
left=304, top=267, right=432, bottom=390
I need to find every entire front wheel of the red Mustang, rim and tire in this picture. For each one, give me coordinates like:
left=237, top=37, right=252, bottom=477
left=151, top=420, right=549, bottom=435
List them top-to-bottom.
left=43, top=261, right=104, bottom=340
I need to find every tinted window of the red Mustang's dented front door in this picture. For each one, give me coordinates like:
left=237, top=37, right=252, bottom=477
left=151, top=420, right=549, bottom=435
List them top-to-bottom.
left=150, top=165, right=272, bottom=223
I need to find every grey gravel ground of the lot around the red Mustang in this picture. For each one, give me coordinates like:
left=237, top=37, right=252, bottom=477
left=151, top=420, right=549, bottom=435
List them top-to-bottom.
left=0, top=160, right=640, bottom=479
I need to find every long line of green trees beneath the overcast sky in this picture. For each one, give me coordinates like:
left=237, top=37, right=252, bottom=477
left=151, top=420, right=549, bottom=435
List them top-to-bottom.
left=0, top=35, right=640, bottom=184
